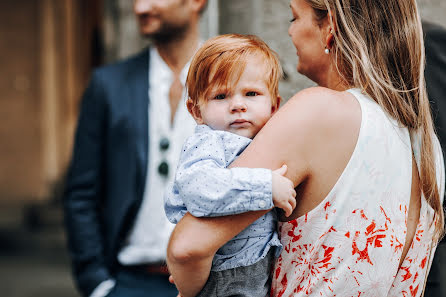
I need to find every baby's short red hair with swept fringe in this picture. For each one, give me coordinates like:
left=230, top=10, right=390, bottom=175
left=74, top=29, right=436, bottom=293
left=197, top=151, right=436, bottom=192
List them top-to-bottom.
left=186, top=34, right=283, bottom=106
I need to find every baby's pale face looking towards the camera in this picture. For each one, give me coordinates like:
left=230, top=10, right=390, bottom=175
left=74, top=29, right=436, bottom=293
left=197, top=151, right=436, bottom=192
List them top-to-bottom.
left=196, top=57, right=277, bottom=138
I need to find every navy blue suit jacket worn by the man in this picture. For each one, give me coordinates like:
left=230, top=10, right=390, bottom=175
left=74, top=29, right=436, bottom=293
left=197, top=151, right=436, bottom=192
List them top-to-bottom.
left=64, top=50, right=149, bottom=296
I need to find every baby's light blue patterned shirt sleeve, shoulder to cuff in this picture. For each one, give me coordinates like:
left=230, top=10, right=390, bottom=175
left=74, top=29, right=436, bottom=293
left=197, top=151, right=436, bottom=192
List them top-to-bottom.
left=166, top=133, right=274, bottom=217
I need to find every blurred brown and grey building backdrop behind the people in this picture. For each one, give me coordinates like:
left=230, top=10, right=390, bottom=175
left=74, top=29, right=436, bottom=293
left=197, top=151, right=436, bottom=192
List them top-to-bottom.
left=0, top=0, right=446, bottom=297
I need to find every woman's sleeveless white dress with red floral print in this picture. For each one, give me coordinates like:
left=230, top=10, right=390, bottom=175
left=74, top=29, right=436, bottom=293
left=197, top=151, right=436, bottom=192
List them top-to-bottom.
left=271, top=89, right=444, bottom=297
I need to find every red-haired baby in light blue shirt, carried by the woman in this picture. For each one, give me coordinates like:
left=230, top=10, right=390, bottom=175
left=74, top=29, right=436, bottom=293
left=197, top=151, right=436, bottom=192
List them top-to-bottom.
left=165, top=34, right=296, bottom=297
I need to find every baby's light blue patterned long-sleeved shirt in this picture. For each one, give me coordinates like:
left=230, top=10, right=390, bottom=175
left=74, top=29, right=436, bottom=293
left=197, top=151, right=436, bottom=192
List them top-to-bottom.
left=164, top=125, right=282, bottom=271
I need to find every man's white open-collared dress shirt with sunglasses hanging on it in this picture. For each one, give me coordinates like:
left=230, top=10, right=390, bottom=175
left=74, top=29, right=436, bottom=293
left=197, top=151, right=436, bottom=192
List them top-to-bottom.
left=118, top=48, right=196, bottom=265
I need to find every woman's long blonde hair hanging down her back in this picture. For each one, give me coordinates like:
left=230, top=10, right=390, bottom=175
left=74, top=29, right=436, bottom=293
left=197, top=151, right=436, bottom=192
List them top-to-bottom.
left=305, top=0, right=444, bottom=240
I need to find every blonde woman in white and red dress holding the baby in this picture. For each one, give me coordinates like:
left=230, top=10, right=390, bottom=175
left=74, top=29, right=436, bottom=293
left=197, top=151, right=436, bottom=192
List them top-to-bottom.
left=168, top=0, right=444, bottom=297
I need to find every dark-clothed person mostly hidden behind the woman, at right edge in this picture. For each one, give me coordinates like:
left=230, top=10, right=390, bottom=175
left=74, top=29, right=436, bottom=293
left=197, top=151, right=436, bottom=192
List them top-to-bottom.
left=423, top=22, right=446, bottom=297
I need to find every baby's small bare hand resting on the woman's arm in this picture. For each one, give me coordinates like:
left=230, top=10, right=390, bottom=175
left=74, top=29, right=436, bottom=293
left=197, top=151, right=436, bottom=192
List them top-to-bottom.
left=272, top=165, right=296, bottom=217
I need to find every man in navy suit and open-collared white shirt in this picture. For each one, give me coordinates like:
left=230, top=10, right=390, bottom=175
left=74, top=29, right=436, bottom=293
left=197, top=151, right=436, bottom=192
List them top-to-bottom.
left=64, top=0, right=206, bottom=297
